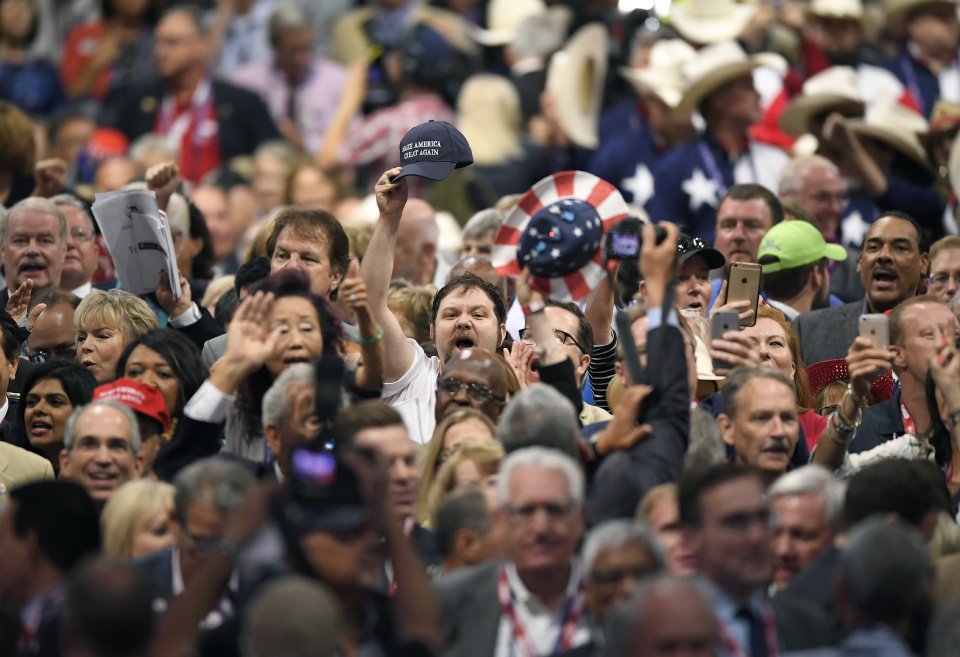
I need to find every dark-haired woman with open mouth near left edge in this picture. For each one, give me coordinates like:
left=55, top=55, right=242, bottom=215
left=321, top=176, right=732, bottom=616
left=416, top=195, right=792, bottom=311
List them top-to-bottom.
left=11, top=360, right=97, bottom=472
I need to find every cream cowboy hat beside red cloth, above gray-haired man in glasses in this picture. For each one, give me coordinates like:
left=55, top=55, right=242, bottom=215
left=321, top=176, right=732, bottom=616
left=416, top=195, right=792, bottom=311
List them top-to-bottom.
left=780, top=66, right=864, bottom=137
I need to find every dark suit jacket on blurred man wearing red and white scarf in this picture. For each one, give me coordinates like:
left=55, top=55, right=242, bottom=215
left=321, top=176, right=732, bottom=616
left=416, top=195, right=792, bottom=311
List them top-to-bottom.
left=105, top=79, right=280, bottom=162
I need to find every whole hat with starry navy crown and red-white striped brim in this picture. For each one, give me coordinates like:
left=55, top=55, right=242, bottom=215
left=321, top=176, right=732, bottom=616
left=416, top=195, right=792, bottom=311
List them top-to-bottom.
left=492, top=171, right=629, bottom=301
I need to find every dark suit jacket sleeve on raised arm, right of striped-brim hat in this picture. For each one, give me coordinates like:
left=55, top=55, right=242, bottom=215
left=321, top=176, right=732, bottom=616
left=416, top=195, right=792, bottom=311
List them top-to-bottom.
left=587, top=326, right=690, bottom=525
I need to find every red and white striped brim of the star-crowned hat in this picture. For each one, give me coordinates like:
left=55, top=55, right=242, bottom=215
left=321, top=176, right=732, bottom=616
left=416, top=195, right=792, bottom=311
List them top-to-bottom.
left=490, top=171, right=630, bottom=301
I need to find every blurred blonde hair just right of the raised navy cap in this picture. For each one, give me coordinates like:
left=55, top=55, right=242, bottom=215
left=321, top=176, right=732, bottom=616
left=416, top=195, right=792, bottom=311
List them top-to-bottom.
left=457, top=73, right=523, bottom=165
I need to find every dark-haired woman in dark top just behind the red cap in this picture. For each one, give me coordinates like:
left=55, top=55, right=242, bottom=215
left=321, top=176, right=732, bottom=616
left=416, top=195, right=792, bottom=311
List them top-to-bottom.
left=116, top=329, right=221, bottom=480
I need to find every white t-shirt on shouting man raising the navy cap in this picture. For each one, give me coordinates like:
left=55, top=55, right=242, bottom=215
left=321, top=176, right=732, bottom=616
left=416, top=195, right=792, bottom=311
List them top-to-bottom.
left=380, top=338, right=440, bottom=444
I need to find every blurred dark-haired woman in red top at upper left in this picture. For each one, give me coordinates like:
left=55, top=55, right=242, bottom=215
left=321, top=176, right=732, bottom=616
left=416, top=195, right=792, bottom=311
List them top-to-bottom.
left=60, top=0, right=155, bottom=100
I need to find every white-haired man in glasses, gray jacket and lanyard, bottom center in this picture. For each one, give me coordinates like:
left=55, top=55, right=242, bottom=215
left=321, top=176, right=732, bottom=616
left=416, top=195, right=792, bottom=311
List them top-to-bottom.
left=437, top=447, right=592, bottom=657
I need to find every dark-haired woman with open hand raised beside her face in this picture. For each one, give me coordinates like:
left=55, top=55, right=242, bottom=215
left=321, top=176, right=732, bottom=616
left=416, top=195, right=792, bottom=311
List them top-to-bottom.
left=188, top=268, right=383, bottom=464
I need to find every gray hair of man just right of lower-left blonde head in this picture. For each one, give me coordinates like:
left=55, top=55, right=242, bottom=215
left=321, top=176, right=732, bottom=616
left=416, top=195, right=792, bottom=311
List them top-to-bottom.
left=173, top=456, right=257, bottom=521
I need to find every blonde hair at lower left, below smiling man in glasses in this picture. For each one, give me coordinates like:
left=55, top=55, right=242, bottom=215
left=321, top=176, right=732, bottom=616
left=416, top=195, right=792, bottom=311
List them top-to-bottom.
left=100, top=479, right=174, bottom=560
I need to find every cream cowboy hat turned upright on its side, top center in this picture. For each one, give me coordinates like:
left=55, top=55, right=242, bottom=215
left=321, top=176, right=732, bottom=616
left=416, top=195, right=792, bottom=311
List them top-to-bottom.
left=547, top=23, right=609, bottom=148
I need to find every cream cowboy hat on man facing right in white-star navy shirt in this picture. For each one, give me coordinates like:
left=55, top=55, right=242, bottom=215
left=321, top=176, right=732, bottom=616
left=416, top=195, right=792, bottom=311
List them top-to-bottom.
left=677, top=41, right=787, bottom=115
